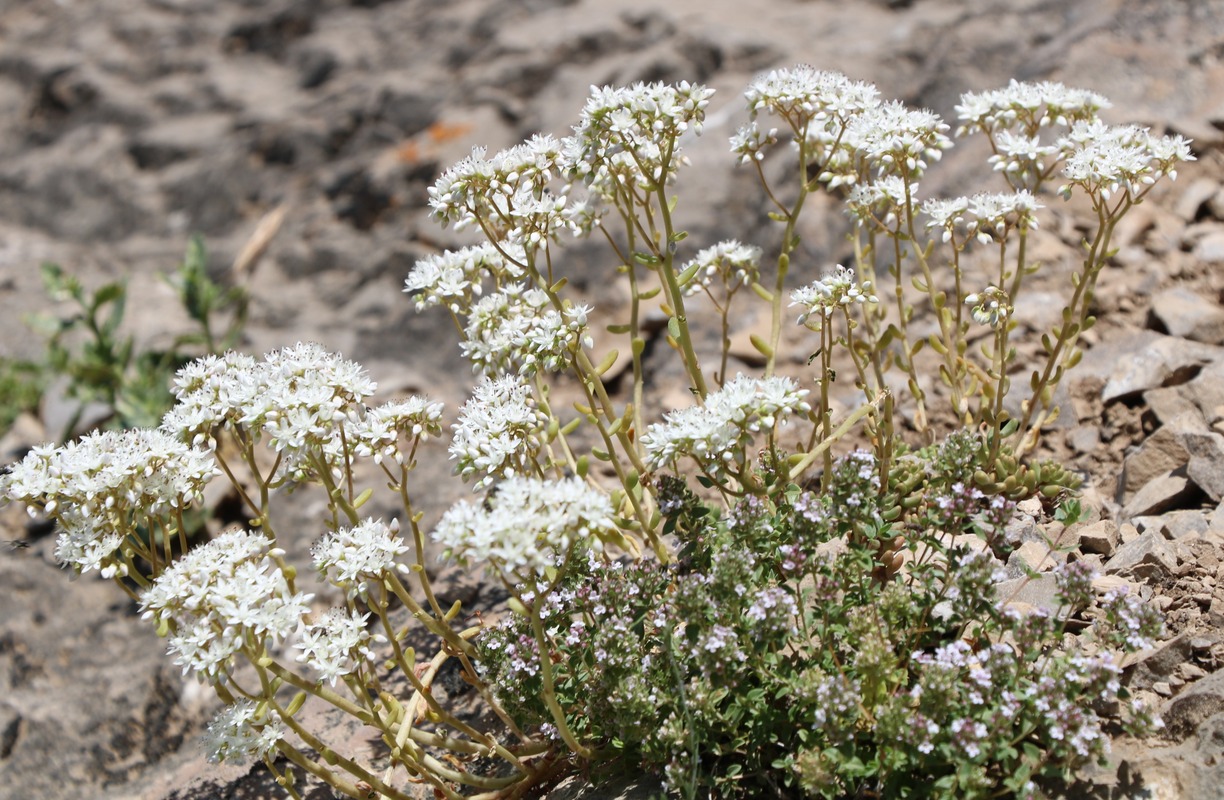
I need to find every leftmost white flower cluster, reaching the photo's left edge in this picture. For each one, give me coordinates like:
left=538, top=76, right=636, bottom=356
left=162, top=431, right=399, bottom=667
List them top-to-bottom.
left=0, top=429, right=219, bottom=577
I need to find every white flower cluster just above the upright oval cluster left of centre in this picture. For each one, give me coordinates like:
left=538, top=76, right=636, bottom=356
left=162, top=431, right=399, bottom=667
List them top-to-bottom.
left=459, top=284, right=594, bottom=376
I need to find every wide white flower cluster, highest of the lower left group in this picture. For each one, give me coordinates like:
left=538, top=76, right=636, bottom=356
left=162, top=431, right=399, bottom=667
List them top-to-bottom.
left=162, top=343, right=442, bottom=480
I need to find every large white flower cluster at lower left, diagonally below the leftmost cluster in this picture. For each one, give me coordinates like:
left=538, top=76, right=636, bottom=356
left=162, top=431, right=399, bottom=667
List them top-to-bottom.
left=141, top=530, right=313, bottom=683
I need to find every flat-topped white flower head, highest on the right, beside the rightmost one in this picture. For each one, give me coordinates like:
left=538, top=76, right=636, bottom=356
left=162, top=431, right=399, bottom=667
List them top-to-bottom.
left=956, top=80, right=1110, bottom=137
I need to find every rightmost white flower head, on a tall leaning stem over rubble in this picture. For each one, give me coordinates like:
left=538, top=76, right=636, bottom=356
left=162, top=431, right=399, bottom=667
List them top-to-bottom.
left=1059, top=120, right=1195, bottom=201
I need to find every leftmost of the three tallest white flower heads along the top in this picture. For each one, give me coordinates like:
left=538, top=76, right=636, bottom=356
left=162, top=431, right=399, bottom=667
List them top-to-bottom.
left=564, top=81, right=714, bottom=198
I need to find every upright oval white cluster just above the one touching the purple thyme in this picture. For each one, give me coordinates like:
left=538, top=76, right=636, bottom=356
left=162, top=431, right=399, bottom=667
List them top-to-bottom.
left=450, top=376, right=548, bottom=491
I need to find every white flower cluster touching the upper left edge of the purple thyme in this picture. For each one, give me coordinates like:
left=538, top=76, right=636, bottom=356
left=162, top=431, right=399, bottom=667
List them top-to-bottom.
left=432, top=476, right=616, bottom=580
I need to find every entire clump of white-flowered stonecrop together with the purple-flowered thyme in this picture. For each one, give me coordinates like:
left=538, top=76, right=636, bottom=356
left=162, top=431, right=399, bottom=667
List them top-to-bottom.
left=2, top=66, right=1192, bottom=799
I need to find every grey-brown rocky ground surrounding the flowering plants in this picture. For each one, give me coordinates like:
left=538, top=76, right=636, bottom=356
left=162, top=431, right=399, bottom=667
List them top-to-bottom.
left=0, top=0, right=1224, bottom=800
